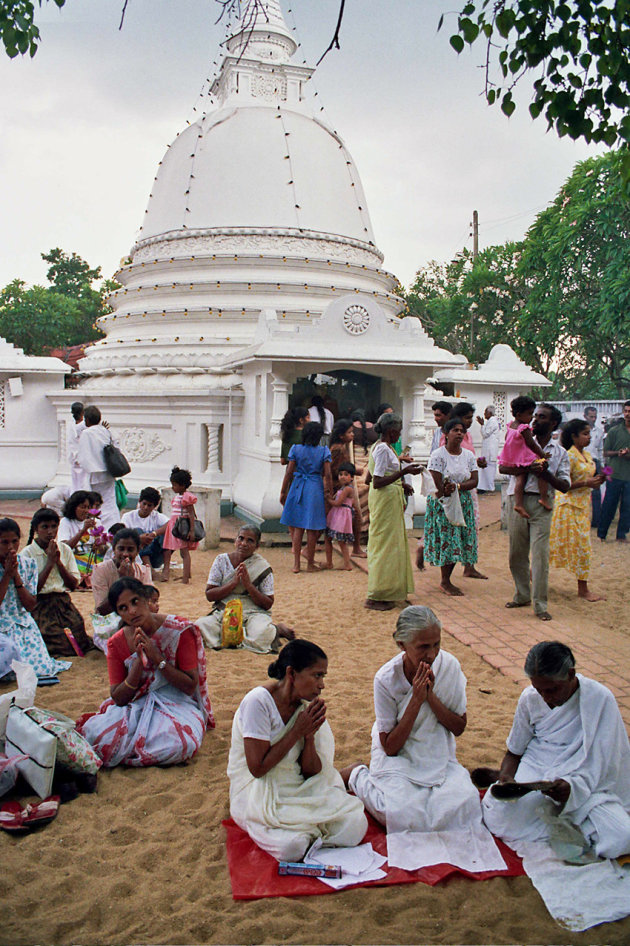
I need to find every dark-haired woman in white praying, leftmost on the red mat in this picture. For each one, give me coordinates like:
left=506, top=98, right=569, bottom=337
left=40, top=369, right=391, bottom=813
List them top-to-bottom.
left=228, top=640, right=367, bottom=861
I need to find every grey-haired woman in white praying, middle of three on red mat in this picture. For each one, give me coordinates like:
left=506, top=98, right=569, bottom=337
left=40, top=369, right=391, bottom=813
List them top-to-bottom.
left=342, top=605, right=505, bottom=871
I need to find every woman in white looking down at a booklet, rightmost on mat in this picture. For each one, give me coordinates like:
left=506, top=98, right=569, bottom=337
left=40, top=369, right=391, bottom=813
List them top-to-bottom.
left=479, top=641, right=630, bottom=857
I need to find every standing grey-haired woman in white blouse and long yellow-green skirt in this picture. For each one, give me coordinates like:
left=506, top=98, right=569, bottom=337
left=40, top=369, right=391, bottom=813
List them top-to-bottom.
left=365, top=413, right=422, bottom=611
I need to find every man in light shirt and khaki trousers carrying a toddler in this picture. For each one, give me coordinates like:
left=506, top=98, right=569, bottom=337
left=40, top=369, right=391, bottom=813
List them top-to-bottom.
left=499, top=404, right=571, bottom=621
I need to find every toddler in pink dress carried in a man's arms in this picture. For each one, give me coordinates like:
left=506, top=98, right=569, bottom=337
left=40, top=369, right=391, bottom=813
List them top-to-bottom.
left=498, top=395, right=553, bottom=519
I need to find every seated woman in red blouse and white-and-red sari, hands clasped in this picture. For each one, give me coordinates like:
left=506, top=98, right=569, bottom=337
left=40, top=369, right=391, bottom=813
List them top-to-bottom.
left=77, top=578, right=214, bottom=768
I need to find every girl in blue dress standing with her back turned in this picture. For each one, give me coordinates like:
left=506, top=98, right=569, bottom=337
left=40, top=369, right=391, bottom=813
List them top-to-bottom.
left=280, top=423, right=332, bottom=573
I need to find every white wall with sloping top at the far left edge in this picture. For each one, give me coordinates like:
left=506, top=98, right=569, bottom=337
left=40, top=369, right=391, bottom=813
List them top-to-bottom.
left=0, top=370, right=64, bottom=490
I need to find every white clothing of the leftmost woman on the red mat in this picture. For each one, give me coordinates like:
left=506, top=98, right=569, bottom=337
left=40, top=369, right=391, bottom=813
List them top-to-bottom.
left=227, top=687, right=367, bottom=861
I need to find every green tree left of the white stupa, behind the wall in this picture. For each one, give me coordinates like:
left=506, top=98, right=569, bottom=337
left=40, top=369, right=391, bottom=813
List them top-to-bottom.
left=0, top=248, right=110, bottom=355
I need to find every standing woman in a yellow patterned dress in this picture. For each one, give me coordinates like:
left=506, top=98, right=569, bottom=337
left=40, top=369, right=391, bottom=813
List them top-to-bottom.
left=549, top=418, right=605, bottom=601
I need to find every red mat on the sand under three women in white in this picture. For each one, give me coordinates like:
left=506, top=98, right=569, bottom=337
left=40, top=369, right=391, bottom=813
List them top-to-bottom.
left=223, top=815, right=525, bottom=900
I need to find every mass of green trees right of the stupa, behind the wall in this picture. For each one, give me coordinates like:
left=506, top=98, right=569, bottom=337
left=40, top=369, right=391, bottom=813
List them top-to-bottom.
left=407, top=151, right=630, bottom=398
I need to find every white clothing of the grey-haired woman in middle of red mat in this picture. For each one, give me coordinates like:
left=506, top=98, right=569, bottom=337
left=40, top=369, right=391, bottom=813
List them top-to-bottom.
left=349, top=651, right=506, bottom=872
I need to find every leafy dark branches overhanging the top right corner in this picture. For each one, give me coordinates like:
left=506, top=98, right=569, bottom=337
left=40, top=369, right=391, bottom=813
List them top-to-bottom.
left=450, top=0, right=630, bottom=146
